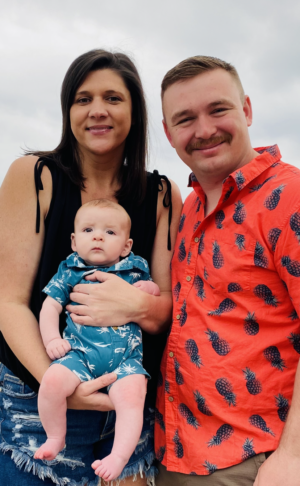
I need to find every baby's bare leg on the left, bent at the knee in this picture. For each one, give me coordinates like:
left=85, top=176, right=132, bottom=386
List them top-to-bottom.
left=34, top=364, right=80, bottom=461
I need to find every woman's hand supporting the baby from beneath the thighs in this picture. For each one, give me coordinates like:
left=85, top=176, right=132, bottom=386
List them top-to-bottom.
left=67, top=373, right=117, bottom=412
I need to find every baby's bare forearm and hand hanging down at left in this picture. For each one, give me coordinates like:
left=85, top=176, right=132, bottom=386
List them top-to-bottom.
left=40, top=295, right=71, bottom=360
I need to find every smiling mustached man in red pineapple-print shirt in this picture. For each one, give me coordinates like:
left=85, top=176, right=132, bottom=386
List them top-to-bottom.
left=156, top=56, right=300, bottom=486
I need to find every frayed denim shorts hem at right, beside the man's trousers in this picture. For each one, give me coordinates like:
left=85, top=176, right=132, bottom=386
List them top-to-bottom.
left=99, top=452, right=158, bottom=486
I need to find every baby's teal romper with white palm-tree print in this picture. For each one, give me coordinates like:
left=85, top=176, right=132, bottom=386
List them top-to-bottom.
left=43, top=252, right=151, bottom=381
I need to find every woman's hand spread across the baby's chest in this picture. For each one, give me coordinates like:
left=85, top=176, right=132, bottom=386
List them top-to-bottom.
left=66, top=271, right=146, bottom=326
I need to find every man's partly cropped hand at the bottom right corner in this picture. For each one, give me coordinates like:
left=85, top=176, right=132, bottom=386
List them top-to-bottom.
left=253, top=446, right=300, bottom=486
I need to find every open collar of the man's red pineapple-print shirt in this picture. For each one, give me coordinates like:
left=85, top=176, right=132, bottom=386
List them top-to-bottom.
left=188, top=145, right=281, bottom=199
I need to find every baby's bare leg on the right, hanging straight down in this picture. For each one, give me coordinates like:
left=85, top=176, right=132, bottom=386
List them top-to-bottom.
left=92, top=375, right=147, bottom=481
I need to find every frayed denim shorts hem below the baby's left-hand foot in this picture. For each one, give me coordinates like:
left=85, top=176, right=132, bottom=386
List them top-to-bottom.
left=0, top=442, right=99, bottom=486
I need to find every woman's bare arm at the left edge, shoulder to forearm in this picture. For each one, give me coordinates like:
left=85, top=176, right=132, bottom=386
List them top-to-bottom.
left=0, top=156, right=52, bottom=381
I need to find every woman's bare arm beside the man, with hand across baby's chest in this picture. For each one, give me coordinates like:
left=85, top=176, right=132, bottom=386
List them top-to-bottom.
left=67, top=178, right=182, bottom=334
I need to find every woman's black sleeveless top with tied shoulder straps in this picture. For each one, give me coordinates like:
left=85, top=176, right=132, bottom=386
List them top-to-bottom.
left=0, top=159, right=172, bottom=399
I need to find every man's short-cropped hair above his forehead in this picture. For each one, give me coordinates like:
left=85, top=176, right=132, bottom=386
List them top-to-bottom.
left=161, top=56, right=245, bottom=102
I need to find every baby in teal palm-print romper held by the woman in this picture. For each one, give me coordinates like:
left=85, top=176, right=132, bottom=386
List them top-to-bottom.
left=34, top=199, right=160, bottom=481
